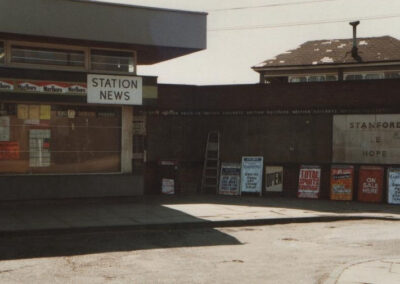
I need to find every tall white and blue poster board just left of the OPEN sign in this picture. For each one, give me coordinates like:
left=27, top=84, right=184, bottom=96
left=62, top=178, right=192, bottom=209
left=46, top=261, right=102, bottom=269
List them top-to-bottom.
left=241, top=157, right=264, bottom=195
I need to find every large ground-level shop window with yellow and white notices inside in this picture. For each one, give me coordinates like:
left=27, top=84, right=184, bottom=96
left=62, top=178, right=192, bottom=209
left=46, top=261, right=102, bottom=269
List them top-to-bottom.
left=0, top=103, right=121, bottom=174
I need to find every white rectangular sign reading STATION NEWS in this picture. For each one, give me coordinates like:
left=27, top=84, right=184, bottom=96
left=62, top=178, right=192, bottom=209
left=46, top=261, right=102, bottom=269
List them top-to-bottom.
left=87, top=74, right=143, bottom=105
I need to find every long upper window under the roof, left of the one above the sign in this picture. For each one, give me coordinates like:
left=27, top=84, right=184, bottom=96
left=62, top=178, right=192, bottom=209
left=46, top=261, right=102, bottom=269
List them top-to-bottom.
left=11, top=45, right=85, bottom=67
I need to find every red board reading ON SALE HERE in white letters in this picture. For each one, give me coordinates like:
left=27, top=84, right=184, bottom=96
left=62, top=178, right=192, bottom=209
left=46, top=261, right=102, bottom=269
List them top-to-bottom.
left=358, top=166, right=384, bottom=202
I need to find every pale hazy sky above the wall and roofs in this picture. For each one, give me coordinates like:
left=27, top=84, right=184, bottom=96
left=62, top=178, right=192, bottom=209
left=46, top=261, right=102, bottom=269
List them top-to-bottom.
left=103, top=0, right=400, bottom=85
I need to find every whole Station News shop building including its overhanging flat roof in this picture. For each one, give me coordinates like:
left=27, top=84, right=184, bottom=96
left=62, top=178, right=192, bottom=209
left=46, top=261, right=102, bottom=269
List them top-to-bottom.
left=0, top=0, right=206, bottom=200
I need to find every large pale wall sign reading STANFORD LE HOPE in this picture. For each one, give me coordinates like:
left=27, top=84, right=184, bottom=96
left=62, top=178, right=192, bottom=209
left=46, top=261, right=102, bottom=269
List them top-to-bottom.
left=333, top=114, right=400, bottom=164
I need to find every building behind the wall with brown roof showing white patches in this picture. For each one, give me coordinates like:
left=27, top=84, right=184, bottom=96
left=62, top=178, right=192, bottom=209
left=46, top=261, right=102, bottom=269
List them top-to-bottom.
left=252, top=36, right=400, bottom=84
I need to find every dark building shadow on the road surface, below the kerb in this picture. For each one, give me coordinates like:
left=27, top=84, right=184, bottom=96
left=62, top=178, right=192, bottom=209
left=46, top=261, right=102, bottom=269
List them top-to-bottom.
left=0, top=208, right=241, bottom=260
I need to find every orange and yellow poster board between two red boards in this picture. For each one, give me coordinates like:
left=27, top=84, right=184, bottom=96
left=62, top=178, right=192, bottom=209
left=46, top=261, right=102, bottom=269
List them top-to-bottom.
left=331, top=166, right=354, bottom=200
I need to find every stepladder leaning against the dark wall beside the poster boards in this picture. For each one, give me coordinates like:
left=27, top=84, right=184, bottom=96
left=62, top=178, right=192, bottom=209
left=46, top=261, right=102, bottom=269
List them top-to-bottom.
left=201, top=131, right=220, bottom=193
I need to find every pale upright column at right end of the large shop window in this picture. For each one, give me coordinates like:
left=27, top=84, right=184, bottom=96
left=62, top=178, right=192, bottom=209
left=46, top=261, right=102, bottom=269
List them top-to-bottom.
left=121, top=106, right=133, bottom=174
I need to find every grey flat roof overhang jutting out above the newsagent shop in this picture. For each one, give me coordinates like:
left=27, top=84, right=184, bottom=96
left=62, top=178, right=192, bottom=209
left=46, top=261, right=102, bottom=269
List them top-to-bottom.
left=0, top=0, right=207, bottom=64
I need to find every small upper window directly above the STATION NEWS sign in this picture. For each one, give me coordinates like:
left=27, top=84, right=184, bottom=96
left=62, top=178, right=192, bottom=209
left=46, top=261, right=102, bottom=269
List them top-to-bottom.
left=90, top=49, right=135, bottom=73
